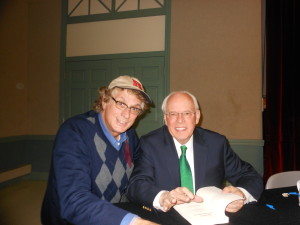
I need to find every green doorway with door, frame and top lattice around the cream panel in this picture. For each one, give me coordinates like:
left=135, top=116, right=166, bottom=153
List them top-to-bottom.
left=60, top=0, right=171, bottom=135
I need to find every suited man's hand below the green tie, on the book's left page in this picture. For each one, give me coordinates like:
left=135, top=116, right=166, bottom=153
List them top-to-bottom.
left=159, top=187, right=203, bottom=212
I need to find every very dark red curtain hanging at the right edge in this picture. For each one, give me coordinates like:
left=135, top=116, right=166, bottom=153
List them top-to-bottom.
left=263, top=0, right=300, bottom=181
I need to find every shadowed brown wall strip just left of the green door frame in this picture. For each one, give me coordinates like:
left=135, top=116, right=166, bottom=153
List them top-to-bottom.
left=28, top=0, right=61, bottom=135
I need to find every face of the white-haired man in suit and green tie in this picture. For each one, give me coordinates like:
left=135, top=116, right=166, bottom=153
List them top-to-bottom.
left=164, top=93, right=200, bottom=144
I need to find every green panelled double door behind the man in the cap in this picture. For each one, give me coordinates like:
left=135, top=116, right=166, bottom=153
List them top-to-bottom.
left=63, top=57, right=166, bottom=135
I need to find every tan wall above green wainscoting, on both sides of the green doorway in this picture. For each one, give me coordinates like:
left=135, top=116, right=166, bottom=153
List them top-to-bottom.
left=0, top=0, right=262, bottom=139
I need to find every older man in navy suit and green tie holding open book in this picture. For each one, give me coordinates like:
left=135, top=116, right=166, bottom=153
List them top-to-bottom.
left=127, top=91, right=263, bottom=212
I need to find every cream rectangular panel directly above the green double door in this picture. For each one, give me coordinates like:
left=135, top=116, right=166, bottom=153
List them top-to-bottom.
left=66, top=16, right=166, bottom=57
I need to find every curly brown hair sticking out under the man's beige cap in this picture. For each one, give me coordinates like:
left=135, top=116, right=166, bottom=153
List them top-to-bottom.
left=93, top=87, right=149, bottom=115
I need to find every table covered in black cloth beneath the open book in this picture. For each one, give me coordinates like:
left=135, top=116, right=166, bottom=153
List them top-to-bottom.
left=116, top=187, right=300, bottom=225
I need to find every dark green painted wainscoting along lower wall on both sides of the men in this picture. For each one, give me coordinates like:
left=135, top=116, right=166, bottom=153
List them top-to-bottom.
left=0, top=135, right=264, bottom=180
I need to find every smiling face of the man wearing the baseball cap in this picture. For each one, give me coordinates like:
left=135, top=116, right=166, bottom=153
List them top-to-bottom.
left=102, top=89, right=142, bottom=139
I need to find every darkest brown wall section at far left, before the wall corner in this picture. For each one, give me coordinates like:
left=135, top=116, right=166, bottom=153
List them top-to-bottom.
left=0, top=0, right=28, bottom=136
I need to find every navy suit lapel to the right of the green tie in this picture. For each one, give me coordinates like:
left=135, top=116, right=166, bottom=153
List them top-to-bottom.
left=193, top=128, right=208, bottom=191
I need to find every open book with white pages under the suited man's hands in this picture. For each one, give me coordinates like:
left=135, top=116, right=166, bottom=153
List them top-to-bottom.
left=174, top=186, right=242, bottom=225
